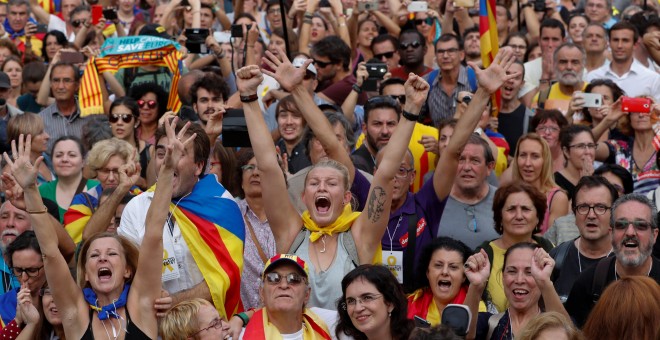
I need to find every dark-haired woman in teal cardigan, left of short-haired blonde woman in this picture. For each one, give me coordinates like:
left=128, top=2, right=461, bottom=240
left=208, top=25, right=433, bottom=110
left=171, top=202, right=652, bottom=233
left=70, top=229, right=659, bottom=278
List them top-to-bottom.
left=39, top=136, right=99, bottom=223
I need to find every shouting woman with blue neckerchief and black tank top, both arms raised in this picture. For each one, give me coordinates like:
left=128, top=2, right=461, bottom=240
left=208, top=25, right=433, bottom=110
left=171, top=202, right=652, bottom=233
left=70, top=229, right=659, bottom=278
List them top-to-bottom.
left=5, top=119, right=187, bottom=339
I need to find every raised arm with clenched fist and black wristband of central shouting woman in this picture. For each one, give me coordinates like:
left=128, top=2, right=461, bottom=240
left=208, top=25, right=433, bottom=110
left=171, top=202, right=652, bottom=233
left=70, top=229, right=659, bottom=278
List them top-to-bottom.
left=236, top=65, right=303, bottom=253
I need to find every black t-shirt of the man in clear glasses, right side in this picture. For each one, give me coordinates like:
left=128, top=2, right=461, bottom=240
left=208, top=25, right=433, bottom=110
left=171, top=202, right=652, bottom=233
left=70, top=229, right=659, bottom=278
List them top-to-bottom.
left=550, top=240, right=602, bottom=302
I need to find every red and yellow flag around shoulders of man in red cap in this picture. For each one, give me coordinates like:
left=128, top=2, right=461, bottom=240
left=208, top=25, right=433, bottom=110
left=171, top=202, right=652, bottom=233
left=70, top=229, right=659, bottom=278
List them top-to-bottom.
left=243, top=307, right=331, bottom=340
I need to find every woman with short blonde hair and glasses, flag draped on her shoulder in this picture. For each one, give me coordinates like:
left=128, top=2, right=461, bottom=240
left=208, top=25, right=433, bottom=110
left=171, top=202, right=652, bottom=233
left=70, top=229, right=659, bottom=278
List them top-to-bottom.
left=64, top=138, right=139, bottom=243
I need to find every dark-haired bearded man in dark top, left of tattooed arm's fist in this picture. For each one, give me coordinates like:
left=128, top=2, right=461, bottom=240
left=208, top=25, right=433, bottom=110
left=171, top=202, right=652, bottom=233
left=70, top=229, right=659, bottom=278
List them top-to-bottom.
left=353, top=96, right=401, bottom=175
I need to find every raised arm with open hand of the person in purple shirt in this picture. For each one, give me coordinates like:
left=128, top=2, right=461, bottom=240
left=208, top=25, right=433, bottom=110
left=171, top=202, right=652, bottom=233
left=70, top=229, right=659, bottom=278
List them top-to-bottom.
left=433, top=48, right=520, bottom=200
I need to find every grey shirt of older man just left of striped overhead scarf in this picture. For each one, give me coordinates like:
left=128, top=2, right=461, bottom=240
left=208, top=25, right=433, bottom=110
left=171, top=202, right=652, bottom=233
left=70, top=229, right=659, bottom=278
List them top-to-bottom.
left=39, top=101, right=87, bottom=151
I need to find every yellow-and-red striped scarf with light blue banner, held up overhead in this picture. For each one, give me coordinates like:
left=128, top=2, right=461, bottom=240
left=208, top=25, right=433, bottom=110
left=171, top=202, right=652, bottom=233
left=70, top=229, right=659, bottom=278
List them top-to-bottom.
left=78, top=35, right=183, bottom=117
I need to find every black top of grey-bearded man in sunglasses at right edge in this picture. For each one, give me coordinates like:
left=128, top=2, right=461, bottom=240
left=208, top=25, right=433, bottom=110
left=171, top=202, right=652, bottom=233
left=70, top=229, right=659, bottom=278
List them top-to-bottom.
left=564, top=257, right=660, bottom=328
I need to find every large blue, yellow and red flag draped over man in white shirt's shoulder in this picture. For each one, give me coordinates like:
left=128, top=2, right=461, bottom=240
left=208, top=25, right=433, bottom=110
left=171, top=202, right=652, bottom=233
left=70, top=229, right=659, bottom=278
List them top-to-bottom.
left=166, top=175, right=245, bottom=319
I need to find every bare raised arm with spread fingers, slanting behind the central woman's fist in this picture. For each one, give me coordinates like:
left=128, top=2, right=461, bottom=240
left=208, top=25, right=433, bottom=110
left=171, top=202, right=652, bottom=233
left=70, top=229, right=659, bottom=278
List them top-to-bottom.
left=264, top=49, right=355, bottom=183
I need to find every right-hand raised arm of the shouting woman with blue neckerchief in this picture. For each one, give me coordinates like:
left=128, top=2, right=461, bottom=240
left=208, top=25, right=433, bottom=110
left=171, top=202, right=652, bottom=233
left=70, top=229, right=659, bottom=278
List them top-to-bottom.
left=128, top=117, right=191, bottom=338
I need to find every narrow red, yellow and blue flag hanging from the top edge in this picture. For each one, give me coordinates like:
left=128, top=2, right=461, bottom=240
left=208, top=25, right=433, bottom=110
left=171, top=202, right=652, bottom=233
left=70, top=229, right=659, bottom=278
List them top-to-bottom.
left=479, top=0, right=502, bottom=117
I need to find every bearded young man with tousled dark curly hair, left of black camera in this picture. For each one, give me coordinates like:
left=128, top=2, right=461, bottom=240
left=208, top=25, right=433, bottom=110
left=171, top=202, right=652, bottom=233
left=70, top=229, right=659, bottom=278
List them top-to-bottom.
left=190, top=72, right=229, bottom=145
